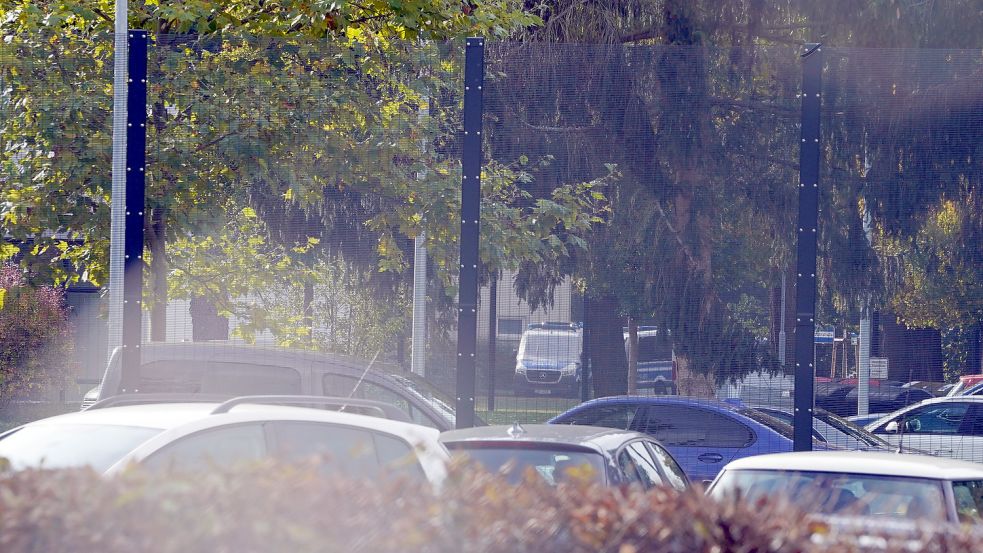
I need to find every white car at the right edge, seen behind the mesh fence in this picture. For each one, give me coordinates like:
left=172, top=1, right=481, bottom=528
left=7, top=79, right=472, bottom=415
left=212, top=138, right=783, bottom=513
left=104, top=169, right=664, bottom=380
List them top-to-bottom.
left=867, top=396, right=983, bottom=463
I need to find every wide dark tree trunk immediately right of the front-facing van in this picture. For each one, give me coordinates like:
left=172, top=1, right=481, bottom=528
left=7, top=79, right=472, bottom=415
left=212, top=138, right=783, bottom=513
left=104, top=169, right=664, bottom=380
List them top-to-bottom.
left=590, top=294, right=628, bottom=397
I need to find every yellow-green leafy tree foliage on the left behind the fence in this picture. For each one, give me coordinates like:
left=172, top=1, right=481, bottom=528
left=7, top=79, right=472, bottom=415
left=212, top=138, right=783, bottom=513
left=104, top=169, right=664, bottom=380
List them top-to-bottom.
left=0, top=1, right=605, bottom=358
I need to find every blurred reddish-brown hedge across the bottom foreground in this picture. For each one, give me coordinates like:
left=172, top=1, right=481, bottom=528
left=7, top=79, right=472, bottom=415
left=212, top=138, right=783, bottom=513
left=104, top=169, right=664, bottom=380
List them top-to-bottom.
left=0, top=464, right=981, bottom=553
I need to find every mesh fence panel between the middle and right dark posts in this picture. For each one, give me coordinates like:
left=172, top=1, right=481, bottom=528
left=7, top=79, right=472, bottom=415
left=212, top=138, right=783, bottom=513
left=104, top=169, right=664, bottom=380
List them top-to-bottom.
left=478, top=44, right=800, bottom=430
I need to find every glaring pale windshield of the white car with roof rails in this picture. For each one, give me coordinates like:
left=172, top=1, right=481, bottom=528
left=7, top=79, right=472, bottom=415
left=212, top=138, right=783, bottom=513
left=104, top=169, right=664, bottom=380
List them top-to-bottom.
left=0, top=424, right=161, bottom=472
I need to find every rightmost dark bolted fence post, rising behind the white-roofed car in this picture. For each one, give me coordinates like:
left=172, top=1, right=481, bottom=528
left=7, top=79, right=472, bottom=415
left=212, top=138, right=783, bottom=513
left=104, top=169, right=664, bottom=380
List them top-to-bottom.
left=793, top=44, right=823, bottom=451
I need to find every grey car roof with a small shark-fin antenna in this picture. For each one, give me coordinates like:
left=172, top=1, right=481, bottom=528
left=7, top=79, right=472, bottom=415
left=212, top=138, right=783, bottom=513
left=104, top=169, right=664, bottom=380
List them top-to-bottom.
left=440, top=424, right=640, bottom=451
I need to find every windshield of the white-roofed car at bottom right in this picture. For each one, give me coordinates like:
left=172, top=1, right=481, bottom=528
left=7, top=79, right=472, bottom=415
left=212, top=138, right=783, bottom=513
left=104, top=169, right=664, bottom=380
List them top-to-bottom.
left=710, top=470, right=946, bottom=521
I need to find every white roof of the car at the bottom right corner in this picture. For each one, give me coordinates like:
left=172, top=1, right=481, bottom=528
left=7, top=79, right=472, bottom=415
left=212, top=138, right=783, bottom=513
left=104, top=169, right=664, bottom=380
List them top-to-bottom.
left=724, top=451, right=983, bottom=480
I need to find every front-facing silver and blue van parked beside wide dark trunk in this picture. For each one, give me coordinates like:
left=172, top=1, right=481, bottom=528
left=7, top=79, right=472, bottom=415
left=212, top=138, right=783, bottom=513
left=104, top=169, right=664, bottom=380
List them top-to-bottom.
left=513, top=323, right=584, bottom=397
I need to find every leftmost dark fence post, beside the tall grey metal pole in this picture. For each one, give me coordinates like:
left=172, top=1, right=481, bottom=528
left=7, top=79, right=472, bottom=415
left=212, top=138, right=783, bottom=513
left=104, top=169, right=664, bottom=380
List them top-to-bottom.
left=120, top=31, right=147, bottom=393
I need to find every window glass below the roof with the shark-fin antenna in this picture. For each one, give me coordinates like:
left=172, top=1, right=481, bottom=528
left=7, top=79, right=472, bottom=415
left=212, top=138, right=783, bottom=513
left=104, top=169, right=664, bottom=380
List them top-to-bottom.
left=446, top=442, right=604, bottom=485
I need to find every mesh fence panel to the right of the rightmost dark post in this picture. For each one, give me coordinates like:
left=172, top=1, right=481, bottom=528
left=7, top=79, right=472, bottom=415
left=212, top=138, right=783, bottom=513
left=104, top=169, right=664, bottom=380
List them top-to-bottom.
left=816, top=49, right=983, bottom=461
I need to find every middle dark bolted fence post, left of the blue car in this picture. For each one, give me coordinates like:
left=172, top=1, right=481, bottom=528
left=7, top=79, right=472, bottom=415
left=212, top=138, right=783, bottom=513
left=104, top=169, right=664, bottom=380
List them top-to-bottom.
left=456, top=38, right=485, bottom=428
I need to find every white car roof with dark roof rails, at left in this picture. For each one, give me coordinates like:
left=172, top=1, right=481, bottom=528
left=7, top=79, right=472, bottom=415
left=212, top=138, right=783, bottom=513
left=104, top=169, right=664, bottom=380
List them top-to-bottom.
left=18, top=402, right=437, bottom=435
